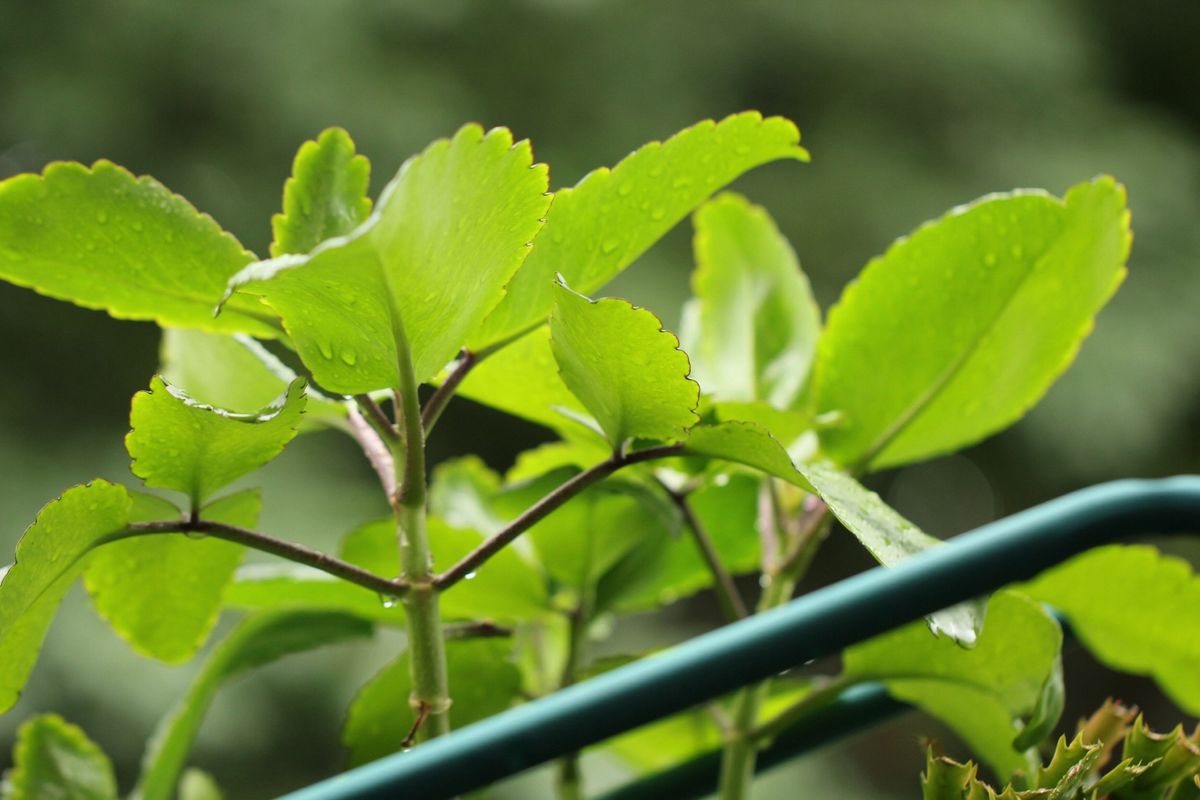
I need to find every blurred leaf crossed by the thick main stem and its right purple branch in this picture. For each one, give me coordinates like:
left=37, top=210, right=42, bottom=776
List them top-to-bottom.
left=342, top=517, right=550, bottom=622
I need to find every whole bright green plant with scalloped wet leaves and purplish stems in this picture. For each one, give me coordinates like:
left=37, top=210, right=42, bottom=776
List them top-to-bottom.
left=0, top=113, right=1200, bottom=800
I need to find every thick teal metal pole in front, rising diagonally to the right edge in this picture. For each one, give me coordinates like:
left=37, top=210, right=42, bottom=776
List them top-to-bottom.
left=278, top=476, right=1200, bottom=800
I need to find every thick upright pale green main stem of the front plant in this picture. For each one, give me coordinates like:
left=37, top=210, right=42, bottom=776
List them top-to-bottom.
left=392, top=313, right=450, bottom=740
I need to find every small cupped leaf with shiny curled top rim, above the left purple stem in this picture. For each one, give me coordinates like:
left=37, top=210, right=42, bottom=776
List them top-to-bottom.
left=125, top=375, right=305, bottom=505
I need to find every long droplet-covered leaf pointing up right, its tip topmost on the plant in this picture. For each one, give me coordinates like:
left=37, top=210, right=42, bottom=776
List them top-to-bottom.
left=470, top=112, right=808, bottom=350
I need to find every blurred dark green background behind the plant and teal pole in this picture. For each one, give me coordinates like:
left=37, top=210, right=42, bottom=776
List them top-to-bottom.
left=0, top=0, right=1200, bottom=799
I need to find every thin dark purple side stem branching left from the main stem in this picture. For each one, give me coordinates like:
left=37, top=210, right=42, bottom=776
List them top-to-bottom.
left=120, top=519, right=408, bottom=597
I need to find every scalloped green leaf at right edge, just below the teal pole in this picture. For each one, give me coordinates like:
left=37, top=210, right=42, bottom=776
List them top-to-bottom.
left=1021, top=545, right=1200, bottom=715
